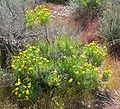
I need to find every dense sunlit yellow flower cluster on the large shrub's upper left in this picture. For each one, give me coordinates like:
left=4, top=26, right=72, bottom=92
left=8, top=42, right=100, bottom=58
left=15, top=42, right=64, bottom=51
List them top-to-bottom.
left=11, top=44, right=49, bottom=72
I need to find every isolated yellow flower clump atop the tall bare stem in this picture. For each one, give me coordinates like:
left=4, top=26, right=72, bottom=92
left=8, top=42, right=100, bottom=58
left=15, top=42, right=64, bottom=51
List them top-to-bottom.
left=25, top=5, right=51, bottom=28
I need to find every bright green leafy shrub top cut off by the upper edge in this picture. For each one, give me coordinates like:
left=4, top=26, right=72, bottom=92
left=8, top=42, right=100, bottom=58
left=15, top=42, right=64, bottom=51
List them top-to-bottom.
left=72, top=0, right=107, bottom=17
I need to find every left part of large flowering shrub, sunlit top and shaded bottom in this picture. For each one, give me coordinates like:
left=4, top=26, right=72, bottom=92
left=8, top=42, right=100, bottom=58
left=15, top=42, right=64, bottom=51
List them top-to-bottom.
left=11, top=44, right=49, bottom=99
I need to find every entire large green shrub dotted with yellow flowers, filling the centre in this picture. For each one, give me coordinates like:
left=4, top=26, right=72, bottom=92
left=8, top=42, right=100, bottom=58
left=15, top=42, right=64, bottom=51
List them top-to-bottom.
left=11, top=34, right=110, bottom=99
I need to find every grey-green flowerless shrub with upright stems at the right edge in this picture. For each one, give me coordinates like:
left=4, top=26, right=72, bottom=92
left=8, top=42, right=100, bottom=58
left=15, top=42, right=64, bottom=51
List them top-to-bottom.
left=99, top=6, right=120, bottom=45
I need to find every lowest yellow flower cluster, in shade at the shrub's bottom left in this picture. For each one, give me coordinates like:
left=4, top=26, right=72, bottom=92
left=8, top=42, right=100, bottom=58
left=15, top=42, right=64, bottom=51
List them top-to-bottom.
left=12, top=77, right=31, bottom=100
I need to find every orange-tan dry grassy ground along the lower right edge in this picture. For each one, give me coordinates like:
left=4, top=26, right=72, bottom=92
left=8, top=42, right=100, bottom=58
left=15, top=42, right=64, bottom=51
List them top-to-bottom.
left=100, top=56, right=120, bottom=109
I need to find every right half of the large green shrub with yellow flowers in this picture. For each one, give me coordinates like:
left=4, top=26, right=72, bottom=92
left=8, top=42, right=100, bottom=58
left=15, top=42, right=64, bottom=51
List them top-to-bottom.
left=50, top=34, right=110, bottom=91
